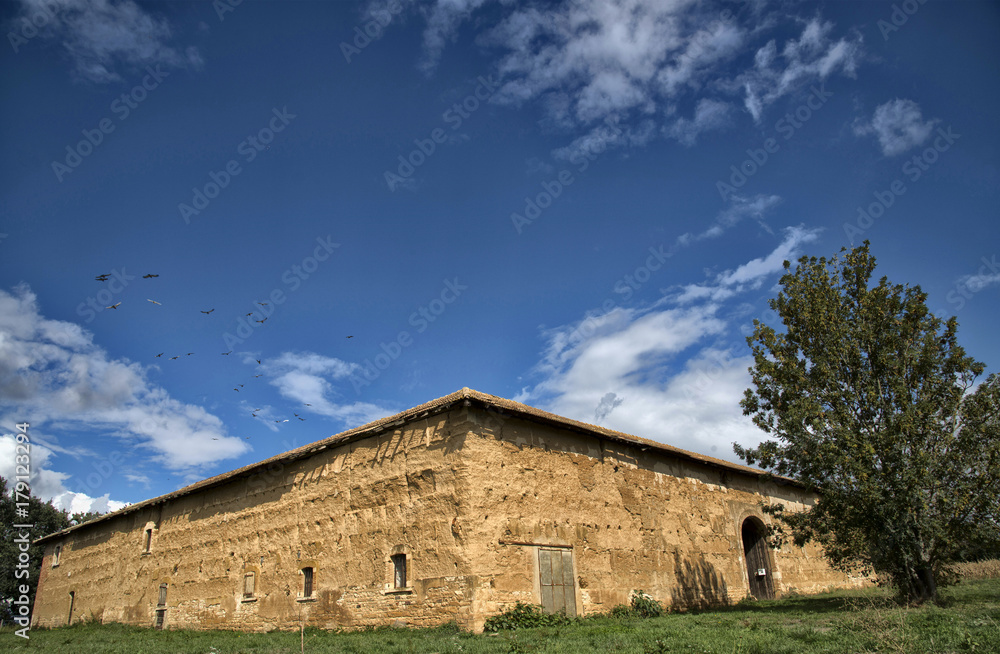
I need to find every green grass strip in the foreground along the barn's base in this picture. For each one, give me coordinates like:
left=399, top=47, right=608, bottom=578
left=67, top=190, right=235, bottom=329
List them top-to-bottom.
left=7, top=579, right=1000, bottom=654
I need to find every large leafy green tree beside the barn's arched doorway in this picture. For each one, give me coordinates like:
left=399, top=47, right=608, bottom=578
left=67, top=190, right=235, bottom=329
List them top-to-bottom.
left=735, top=241, right=1000, bottom=602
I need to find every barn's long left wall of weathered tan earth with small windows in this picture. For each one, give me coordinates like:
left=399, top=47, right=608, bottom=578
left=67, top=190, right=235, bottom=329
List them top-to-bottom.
left=33, top=411, right=484, bottom=630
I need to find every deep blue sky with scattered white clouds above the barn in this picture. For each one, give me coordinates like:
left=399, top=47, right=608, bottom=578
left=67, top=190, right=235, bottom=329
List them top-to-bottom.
left=0, top=0, right=1000, bottom=510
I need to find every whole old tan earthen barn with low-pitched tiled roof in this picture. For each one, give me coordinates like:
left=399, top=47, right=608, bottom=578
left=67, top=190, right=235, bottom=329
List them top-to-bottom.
left=32, top=388, right=861, bottom=630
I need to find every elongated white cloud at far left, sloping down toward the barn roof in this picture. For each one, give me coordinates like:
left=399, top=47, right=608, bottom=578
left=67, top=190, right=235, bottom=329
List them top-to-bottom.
left=0, top=285, right=249, bottom=469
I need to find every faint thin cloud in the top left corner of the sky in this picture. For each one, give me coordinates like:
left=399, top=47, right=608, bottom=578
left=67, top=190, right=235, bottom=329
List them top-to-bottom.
left=14, top=0, right=202, bottom=83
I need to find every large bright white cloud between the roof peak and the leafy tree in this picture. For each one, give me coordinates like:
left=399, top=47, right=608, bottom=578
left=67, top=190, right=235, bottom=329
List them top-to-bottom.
left=516, top=232, right=818, bottom=462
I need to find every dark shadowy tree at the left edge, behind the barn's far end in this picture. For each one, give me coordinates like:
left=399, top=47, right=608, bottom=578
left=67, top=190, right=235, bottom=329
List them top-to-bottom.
left=0, top=477, right=70, bottom=624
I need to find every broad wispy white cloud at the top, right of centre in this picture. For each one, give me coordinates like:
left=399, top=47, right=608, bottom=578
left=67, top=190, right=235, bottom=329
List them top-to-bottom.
left=382, top=0, right=862, bottom=159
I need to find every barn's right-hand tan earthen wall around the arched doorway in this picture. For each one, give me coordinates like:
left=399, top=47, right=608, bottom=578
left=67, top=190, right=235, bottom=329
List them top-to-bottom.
left=459, top=412, right=865, bottom=626
